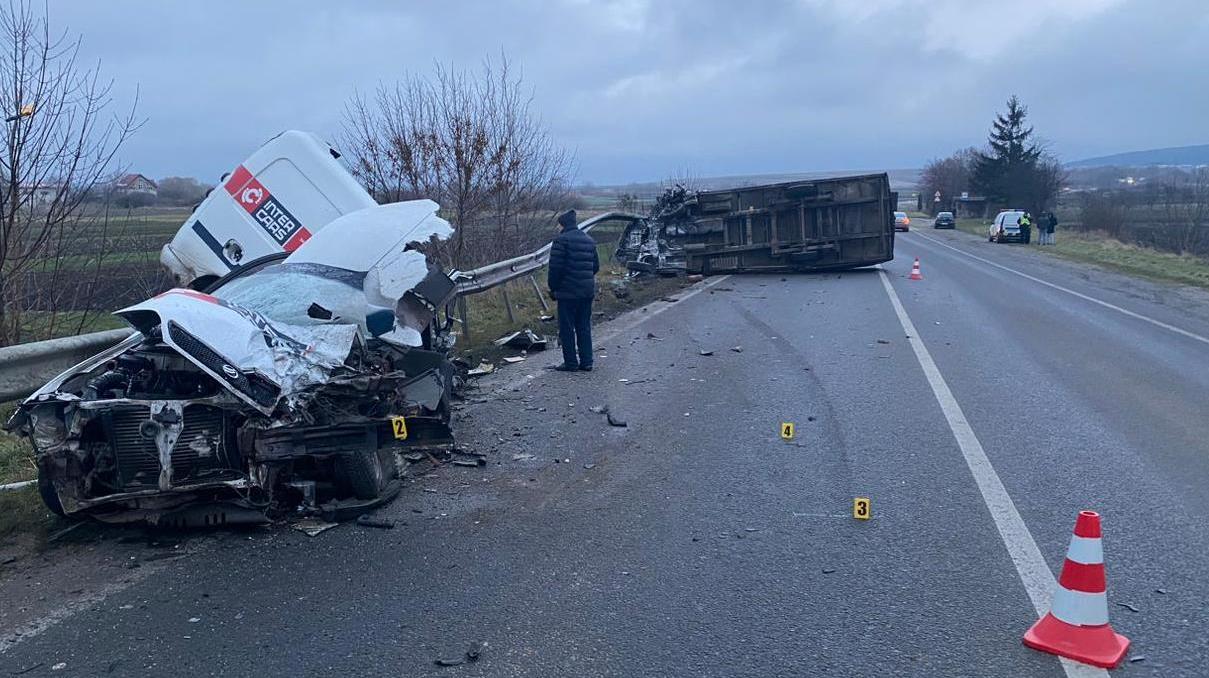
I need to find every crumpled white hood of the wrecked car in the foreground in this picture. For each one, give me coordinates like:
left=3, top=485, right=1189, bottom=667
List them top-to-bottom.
left=116, top=289, right=358, bottom=413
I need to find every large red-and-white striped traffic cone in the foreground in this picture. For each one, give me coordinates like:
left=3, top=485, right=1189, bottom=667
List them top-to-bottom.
left=1024, top=511, right=1129, bottom=668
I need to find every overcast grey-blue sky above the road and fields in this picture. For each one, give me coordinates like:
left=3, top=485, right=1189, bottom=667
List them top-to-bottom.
left=50, top=0, right=1209, bottom=184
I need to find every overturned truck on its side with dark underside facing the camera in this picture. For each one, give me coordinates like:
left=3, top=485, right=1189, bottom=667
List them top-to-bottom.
left=615, top=174, right=897, bottom=274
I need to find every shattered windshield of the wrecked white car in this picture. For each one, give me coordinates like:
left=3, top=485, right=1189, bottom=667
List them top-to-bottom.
left=214, top=263, right=369, bottom=329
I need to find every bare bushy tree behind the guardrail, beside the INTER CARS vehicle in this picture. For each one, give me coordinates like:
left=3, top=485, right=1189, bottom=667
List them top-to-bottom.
left=342, top=58, right=573, bottom=266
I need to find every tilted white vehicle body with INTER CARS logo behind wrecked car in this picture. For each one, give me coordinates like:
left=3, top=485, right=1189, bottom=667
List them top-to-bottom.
left=160, top=131, right=377, bottom=289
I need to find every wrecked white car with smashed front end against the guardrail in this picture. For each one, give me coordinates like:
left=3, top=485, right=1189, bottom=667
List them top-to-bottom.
left=6, top=201, right=455, bottom=526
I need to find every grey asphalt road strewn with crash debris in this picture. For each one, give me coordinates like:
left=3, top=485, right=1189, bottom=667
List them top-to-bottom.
left=0, top=223, right=1209, bottom=677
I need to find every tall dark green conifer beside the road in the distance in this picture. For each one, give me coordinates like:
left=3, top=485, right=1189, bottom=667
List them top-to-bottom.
left=972, top=94, right=1043, bottom=207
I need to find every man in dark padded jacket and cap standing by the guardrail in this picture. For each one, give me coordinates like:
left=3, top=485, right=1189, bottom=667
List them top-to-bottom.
left=549, top=209, right=601, bottom=372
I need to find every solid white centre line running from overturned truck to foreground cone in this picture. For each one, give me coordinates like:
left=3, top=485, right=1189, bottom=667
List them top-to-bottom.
left=879, top=270, right=1107, bottom=677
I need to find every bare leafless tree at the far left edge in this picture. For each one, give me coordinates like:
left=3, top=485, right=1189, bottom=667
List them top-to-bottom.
left=0, top=0, right=138, bottom=346
